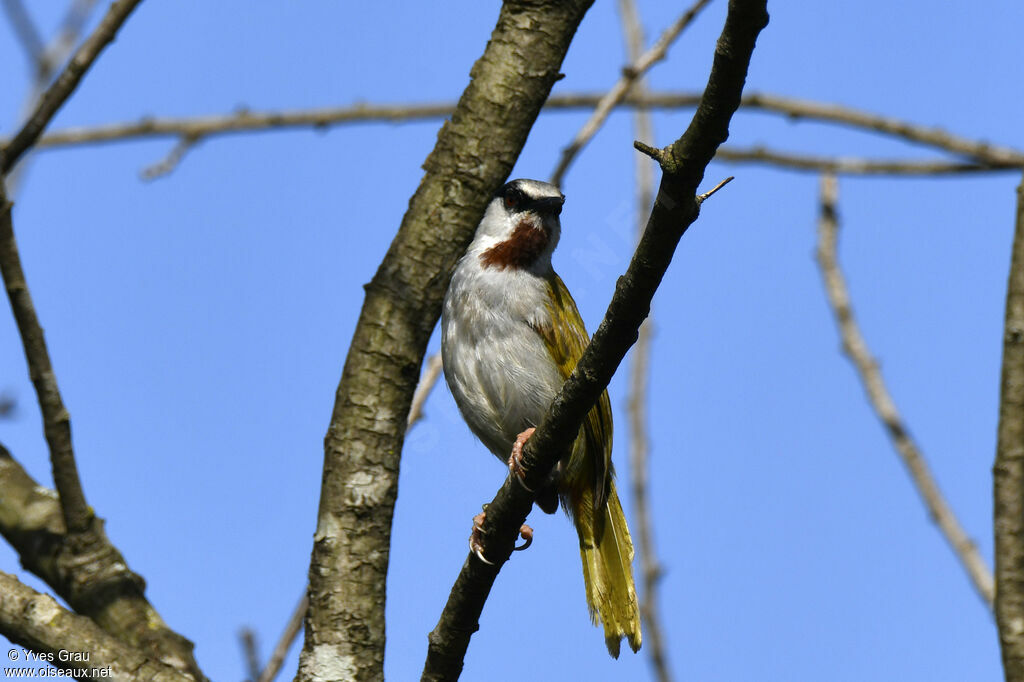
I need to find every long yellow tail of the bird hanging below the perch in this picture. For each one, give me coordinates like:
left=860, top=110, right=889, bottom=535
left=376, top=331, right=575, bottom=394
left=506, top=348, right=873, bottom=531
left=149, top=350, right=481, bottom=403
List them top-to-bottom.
left=572, top=482, right=641, bottom=658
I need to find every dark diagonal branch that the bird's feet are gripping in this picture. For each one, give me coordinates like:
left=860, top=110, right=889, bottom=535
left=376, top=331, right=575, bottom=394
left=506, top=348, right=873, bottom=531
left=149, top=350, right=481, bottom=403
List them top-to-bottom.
left=423, top=0, right=768, bottom=680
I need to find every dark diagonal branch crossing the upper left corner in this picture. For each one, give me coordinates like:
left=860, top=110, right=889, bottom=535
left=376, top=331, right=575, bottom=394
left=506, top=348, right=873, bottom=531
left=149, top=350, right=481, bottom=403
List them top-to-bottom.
left=0, top=0, right=148, bottom=176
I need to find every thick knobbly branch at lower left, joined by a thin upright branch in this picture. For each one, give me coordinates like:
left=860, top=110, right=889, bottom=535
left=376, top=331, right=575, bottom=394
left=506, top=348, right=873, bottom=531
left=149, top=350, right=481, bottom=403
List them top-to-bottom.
left=0, top=445, right=203, bottom=680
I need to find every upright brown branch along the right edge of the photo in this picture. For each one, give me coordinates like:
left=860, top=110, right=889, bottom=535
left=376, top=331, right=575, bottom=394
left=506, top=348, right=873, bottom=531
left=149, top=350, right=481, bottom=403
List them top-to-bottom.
left=992, top=173, right=1024, bottom=682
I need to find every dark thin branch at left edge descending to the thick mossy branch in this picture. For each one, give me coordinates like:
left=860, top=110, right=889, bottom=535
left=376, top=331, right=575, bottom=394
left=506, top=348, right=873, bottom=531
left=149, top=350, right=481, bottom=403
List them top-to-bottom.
left=0, top=180, right=92, bottom=532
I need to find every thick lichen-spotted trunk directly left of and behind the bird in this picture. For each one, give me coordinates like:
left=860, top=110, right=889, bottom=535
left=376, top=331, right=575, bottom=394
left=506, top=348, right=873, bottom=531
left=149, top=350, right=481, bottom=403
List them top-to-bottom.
left=298, top=0, right=591, bottom=680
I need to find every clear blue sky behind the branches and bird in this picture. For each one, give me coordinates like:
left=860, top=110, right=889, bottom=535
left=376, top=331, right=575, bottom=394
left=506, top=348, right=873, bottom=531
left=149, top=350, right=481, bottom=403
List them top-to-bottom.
left=0, top=0, right=1024, bottom=681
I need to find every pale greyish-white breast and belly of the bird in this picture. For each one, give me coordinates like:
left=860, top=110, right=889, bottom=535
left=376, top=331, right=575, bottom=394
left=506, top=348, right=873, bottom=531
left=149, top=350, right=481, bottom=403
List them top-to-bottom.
left=441, top=244, right=562, bottom=461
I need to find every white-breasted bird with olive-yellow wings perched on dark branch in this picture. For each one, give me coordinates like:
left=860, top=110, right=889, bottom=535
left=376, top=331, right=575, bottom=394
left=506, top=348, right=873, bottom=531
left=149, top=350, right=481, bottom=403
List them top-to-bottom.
left=441, top=179, right=642, bottom=658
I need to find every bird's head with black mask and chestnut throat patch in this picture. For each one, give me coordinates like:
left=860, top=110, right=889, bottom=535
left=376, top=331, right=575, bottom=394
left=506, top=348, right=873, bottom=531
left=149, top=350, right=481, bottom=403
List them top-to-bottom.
left=474, top=179, right=565, bottom=269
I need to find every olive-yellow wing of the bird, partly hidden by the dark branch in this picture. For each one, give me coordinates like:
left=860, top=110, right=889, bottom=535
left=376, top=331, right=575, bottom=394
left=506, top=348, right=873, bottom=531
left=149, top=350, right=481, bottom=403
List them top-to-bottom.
left=538, top=274, right=611, bottom=511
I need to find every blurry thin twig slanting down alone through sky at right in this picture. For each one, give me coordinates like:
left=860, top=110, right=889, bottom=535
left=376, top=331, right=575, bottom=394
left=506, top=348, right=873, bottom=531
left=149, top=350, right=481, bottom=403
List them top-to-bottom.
left=816, top=175, right=994, bottom=608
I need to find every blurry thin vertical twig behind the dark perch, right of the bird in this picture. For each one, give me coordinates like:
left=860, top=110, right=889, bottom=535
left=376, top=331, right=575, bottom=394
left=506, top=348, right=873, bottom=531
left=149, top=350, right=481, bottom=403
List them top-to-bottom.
left=618, top=0, right=672, bottom=682
